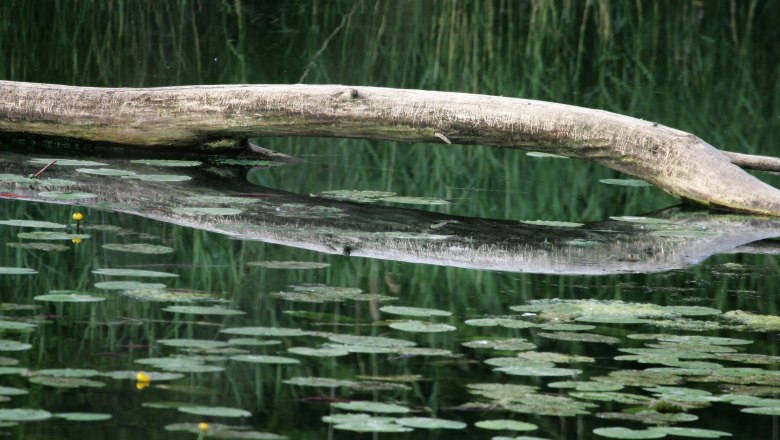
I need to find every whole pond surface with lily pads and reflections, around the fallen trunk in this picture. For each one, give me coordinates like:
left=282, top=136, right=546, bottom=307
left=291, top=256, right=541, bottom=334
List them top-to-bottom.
left=0, top=0, right=780, bottom=440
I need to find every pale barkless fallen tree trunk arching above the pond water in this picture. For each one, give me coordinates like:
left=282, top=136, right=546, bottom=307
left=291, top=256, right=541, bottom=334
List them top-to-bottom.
left=0, top=81, right=780, bottom=216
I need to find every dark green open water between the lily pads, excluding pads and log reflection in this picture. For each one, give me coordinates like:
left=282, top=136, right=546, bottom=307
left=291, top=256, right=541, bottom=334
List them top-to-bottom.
left=0, top=1, right=780, bottom=439
